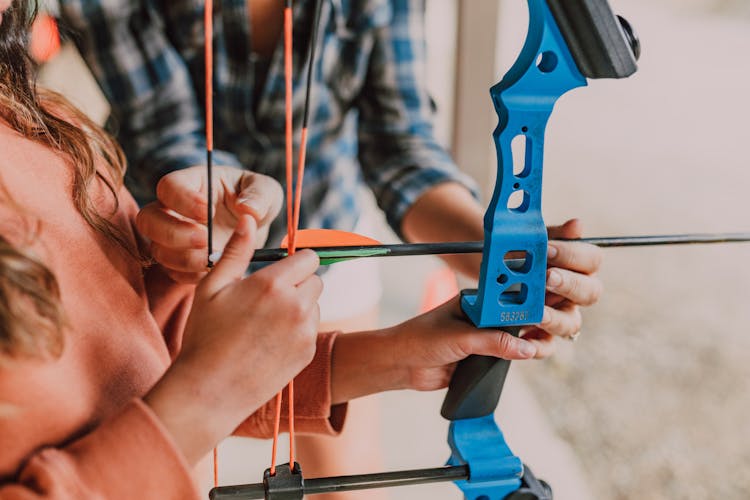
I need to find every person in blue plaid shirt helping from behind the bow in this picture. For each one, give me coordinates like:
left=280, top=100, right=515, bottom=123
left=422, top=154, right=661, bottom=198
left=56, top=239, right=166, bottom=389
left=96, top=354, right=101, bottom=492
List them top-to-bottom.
left=53, top=0, right=601, bottom=492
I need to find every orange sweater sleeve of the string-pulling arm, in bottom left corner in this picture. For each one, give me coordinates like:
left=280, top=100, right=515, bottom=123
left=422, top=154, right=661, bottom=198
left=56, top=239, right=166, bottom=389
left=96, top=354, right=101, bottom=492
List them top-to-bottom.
left=0, top=399, right=199, bottom=500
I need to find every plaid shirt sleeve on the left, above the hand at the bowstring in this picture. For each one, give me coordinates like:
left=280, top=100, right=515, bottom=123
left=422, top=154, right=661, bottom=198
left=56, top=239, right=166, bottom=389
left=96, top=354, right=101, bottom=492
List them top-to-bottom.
left=60, top=0, right=240, bottom=201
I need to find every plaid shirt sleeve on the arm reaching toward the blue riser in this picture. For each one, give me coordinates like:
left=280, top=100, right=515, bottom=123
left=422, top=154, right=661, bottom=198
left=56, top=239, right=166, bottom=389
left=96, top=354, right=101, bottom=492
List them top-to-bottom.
left=358, top=0, right=477, bottom=237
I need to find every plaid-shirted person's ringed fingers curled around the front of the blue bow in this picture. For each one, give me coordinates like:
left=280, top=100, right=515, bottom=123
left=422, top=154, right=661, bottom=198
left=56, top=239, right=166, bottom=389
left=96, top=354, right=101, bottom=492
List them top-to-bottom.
left=521, top=219, right=603, bottom=357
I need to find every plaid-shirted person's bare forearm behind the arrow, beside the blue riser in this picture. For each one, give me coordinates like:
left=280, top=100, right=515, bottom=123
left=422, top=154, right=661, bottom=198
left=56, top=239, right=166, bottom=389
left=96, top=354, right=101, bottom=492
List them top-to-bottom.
left=401, top=182, right=484, bottom=277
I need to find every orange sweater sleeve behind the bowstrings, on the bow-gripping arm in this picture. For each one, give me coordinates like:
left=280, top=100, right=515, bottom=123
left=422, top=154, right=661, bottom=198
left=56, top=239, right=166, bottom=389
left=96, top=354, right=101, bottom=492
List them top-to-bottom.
left=234, top=333, right=347, bottom=438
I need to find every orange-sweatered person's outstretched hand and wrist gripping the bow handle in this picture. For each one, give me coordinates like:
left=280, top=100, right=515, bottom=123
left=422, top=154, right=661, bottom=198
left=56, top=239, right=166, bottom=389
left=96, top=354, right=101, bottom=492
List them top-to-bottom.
left=331, top=298, right=539, bottom=403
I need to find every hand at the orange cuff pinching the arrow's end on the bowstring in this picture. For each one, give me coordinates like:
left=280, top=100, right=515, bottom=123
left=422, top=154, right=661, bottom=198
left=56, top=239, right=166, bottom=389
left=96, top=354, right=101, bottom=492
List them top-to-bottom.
left=145, top=216, right=322, bottom=463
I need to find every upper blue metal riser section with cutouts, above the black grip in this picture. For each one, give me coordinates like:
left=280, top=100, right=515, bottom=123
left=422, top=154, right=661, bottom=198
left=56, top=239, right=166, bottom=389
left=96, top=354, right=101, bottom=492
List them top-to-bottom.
left=461, top=0, right=586, bottom=328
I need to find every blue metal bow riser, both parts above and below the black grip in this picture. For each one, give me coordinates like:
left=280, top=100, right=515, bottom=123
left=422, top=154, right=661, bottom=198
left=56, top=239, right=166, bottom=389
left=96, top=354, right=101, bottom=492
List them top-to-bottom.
left=448, top=0, right=586, bottom=500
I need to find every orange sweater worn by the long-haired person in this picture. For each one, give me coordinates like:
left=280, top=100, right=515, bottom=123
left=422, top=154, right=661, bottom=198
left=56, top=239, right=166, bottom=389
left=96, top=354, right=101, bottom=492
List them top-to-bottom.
left=0, top=121, right=345, bottom=500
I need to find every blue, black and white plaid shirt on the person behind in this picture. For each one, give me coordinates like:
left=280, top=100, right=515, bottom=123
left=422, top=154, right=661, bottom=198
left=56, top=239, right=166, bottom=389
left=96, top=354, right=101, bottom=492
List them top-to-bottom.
left=60, top=0, right=478, bottom=244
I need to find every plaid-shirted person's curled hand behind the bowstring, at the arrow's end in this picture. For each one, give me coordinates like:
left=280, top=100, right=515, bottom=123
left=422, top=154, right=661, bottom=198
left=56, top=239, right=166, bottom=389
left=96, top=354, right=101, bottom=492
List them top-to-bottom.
left=136, top=166, right=283, bottom=283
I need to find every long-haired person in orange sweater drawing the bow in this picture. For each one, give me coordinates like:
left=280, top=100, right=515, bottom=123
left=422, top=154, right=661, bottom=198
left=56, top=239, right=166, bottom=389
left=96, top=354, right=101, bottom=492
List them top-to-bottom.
left=0, top=0, right=588, bottom=500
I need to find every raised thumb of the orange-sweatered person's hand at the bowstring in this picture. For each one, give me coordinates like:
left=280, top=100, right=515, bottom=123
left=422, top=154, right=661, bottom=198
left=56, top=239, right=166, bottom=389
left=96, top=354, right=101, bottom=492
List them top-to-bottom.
left=199, top=215, right=257, bottom=296
